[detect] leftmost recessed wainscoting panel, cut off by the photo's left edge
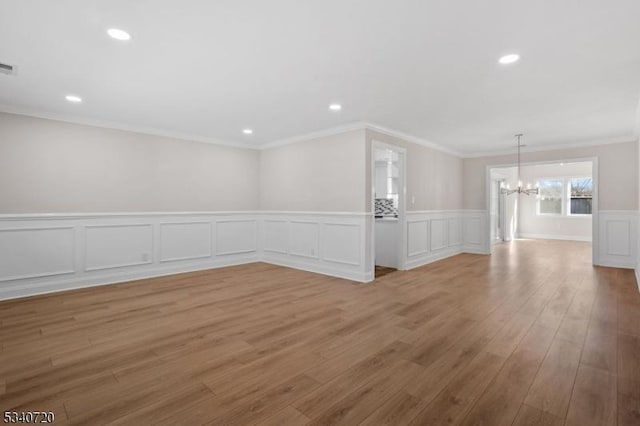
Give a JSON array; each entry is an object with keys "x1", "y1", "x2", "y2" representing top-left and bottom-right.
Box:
[{"x1": 0, "y1": 227, "x2": 75, "y2": 281}]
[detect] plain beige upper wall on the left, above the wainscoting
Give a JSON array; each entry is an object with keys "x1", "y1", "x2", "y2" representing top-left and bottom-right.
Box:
[{"x1": 0, "y1": 113, "x2": 260, "y2": 213}]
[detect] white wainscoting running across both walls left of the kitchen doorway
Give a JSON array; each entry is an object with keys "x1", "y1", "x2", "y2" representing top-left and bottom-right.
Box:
[{"x1": 0, "y1": 211, "x2": 373, "y2": 300}]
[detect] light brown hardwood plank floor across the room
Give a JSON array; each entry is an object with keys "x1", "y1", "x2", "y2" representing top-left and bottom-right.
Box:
[{"x1": 0, "y1": 241, "x2": 640, "y2": 426}]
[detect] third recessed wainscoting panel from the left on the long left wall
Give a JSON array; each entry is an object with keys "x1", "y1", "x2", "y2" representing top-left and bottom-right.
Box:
[{"x1": 160, "y1": 222, "x2": 212, "y2": 262}]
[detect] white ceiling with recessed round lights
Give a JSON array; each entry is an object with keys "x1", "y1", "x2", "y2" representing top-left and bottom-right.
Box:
[{"x1": 0, "y1": 0, "x2": 640, "y2": 153}]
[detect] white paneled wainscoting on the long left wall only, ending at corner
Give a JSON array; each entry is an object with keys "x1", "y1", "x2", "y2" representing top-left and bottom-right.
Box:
[{"x1": 0, "y1": 212, "x2": 261, "y2": 300}]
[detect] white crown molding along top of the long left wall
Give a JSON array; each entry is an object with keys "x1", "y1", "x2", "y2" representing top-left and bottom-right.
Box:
[{"x1": 0, "y1": 104, "x2": 259, "y2": 149}]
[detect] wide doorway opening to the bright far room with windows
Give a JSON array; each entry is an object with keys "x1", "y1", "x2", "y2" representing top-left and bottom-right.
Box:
[{"x1": 487, "y1": 158, "x2": 598, "y2": 264}]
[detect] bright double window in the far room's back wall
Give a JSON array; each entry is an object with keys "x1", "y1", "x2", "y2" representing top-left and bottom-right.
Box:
[{"x1": 536, "y1": 177, "x2": 593, "y2": 216}]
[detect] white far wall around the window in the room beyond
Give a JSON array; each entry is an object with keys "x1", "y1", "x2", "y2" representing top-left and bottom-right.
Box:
[{"x1": 519, "y1": 162, "x2": 592, "y2": 241}]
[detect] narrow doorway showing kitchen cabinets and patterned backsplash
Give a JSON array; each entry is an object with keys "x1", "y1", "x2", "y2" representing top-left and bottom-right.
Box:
[{"x1": 371, "y1": 141, "x2": 406, "y2": 278}]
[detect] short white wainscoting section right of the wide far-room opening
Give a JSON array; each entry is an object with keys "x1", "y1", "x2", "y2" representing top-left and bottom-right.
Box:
[{"x1": 598, "y1": 210, "x2": 638, "y2": 268}]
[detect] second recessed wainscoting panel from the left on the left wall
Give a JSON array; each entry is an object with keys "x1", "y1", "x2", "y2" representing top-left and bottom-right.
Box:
[{"x1": 84, "y1": 224, "x2": 153, "y2": 271}]
